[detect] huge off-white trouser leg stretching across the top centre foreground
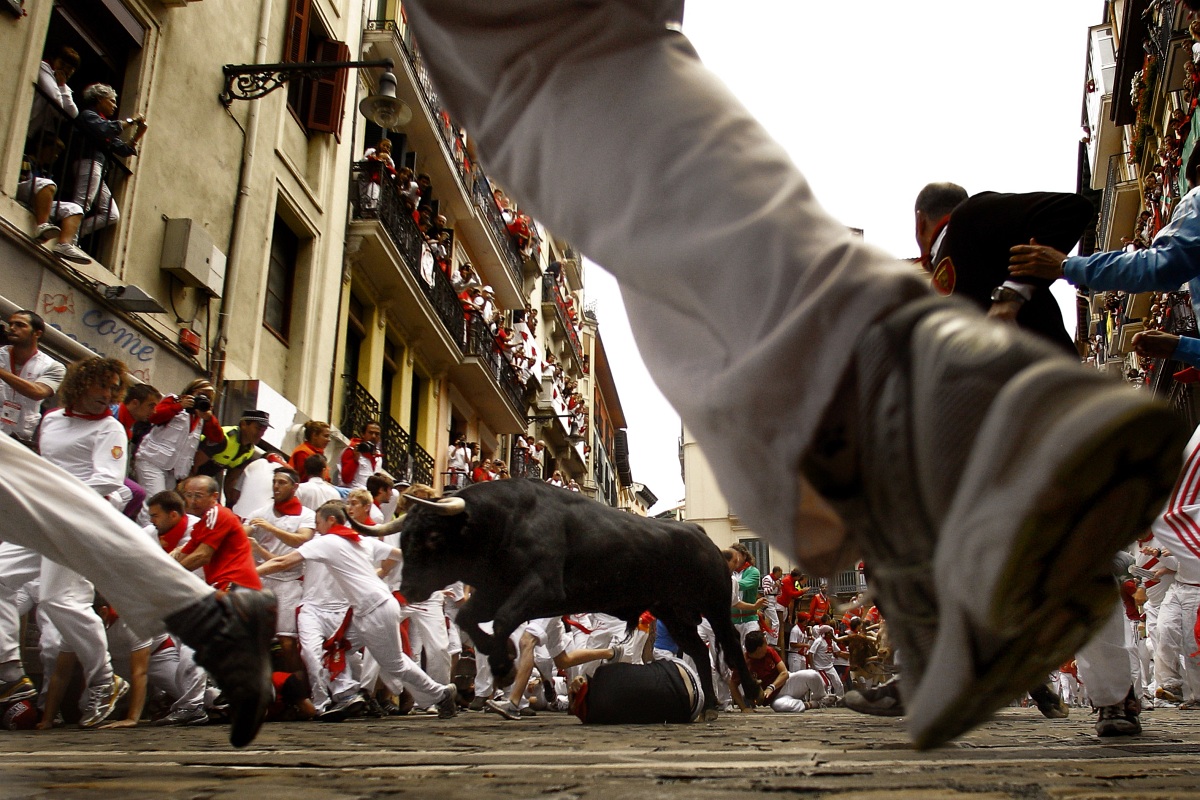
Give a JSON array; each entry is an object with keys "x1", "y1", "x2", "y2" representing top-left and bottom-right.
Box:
[{"x1": 404, "y1": 0, "x2": 929, "y2": 560}]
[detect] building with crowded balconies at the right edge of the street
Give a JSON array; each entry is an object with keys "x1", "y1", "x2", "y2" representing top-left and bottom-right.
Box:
[{"x1": 1076, "y1": 0, "x2": 1200, "y2": 425}]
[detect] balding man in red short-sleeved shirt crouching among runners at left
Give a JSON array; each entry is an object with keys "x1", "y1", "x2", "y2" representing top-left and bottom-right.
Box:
[{"x1": 173, "y1": 475, "x2": 263, "y2": 590}]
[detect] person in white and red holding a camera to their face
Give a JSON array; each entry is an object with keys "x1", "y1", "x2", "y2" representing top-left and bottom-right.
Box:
[{"x1": 134, "y1": 378, "x2": 224, "y2": 497}]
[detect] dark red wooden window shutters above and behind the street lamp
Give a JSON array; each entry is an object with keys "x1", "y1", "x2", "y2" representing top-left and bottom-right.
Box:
[{"x1": 283, "y1": 0, "x2": 350, "y2": 133}]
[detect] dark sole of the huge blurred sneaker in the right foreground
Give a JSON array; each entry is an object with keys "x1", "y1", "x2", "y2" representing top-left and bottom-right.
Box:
[{"x1": 910, "y1": 401, "x2": 1188, "y2": 750}]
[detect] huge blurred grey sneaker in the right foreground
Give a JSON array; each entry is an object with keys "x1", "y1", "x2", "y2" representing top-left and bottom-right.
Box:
[{"x1": 805, "y1": 297, "x2": 1189, "y2": 747}]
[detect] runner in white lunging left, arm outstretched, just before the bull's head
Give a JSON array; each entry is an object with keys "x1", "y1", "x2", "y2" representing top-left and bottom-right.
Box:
[{"x1": 258, "y1": 503, "x2": 458, "y2": 717}]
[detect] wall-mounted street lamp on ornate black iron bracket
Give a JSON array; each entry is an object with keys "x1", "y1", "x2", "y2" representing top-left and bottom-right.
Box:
[{"x1": 218, "y1": 59, "x2": 413, "y2": 128}]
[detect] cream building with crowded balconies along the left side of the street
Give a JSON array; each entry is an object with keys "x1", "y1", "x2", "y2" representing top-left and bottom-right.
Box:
[{"x1": 0, "y1": 0, "x2": 648, "y2": 504}]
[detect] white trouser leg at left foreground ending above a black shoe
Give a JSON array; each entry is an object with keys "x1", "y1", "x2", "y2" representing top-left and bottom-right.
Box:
[{"x1": 0, "y1": 437, "x2": 212, "y2": 637}]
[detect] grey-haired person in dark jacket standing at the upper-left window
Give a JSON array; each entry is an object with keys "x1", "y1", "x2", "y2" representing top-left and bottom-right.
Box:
[{"x1": 71, "y1": 83, "x2": 146, "y2": 242}]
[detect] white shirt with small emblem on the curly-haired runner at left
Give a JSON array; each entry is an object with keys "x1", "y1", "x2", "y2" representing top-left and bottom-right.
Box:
[{"x1": 38, "y1": 408, "x2": 130, "y2": 497}]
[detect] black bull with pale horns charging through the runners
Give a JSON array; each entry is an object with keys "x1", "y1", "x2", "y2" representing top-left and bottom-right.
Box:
[{"x1": 355, "y1": 480, "x2": 758, "y2": 709}]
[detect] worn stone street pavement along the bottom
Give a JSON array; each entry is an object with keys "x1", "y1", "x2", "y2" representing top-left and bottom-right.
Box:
[{"x1": 0, "y1": 709, "x2": 1200, "y2": 800}]
